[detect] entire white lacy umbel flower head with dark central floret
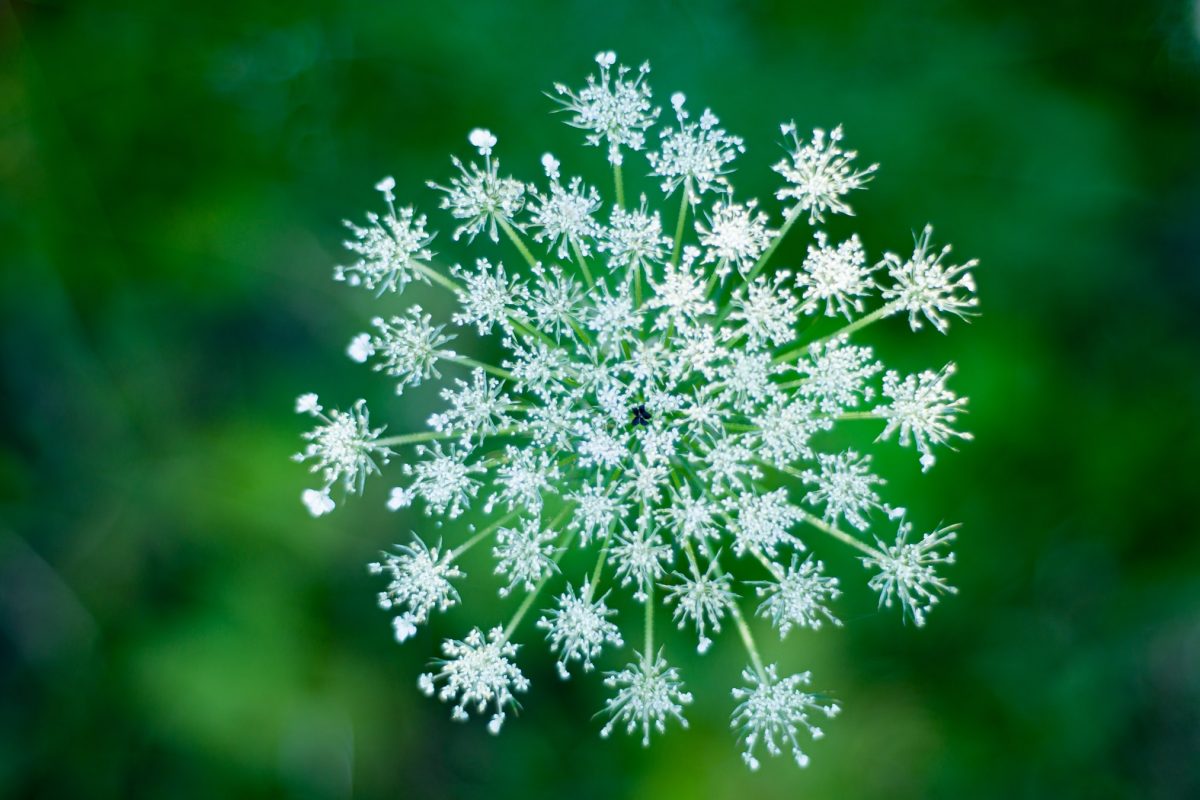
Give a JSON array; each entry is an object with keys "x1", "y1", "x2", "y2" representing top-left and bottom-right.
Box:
[{"x1": 296, "y1": 53, "x2": 977, "y2": 768}]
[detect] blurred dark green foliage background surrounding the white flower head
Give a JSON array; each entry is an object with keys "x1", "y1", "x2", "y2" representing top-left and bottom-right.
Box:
[{"x1": 0, "y1": 0, "x2": 1200, "y2": 800}]
